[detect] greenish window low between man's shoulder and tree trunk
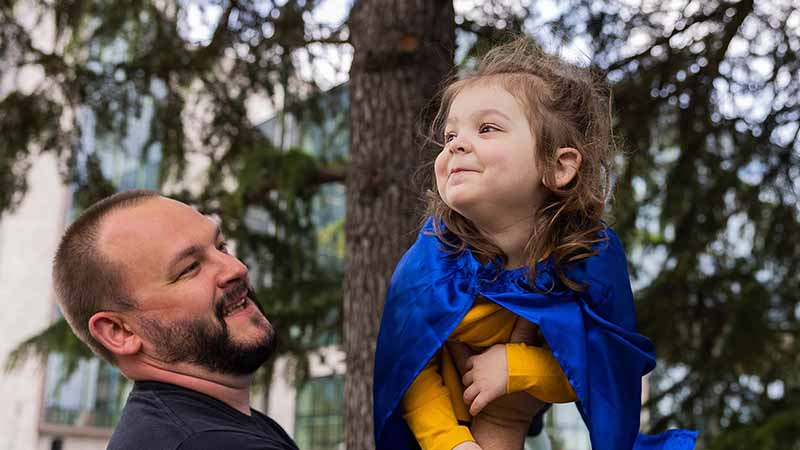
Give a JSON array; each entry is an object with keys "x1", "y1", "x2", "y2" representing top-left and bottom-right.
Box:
[{"x1": 294, "y1": 375, "x2": 344, "y2": 450}]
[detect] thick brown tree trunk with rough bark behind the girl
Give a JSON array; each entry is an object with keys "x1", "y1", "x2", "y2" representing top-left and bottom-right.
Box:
[{"x1": 344, "y1": 0, "x2": 455, "y2": 450}]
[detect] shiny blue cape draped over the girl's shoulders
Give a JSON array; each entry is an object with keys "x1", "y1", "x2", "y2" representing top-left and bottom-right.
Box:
[{"x1": 373, "y1": 219, "x2": 696, "y2": 450}]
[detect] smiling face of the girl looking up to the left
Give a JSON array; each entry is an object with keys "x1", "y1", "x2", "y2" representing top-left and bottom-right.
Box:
[{"x1": 434, "y1": 83, "x2": 545, "y2": 228}]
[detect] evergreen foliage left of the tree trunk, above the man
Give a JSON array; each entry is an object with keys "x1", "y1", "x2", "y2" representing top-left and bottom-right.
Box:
[{"x1": 0, "y1": 0, "x2": 347, "y2": 390}]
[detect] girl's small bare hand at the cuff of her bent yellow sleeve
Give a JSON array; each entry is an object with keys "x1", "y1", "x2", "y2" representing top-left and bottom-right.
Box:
[{"x1": 462, "y1": 344, "x2": 508, "y2": 416}]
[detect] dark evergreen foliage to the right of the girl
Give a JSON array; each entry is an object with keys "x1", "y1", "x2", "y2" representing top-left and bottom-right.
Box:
[{"x1": 557, "y1": 1, "x2": 800, "y2": 449}]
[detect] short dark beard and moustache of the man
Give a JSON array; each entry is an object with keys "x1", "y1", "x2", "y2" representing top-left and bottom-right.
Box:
[{"x1": 141, "y1": 286, "x2": 276, "y2": 375}]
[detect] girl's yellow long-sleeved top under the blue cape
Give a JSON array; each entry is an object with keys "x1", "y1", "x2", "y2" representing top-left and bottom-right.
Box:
[{"x1": 402, "y1": 297, "x2": 576, "y2": 450}]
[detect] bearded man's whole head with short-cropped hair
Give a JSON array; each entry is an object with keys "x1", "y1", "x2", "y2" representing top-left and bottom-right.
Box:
[{"x1": 53, "y1": 191, "x2": 274, "y2": 375}]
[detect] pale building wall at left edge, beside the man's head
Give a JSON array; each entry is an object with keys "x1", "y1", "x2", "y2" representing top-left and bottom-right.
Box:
[{"x1": 0, "y1": 154, "x2": 68, "y2": 450}]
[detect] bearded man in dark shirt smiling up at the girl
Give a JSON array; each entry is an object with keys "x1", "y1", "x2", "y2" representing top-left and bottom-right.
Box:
[{"x1": 53, "y1": 190, "x2": 297, "y2": 450}]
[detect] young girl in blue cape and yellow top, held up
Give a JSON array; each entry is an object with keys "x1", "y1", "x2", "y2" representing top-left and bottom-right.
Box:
[{"x1": 374, "y1": 38, "x2": 695, "y2": 450}]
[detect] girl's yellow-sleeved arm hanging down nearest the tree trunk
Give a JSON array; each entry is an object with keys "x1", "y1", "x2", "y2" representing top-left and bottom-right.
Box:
[{"x1": 401, "y1": 350, "x2": 480, "y2": 450}]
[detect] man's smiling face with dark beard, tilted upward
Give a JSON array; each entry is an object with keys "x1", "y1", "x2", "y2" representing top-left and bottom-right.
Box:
[{"x1": 99, "y1": 197, "x2": 275, "y2": 375}]
